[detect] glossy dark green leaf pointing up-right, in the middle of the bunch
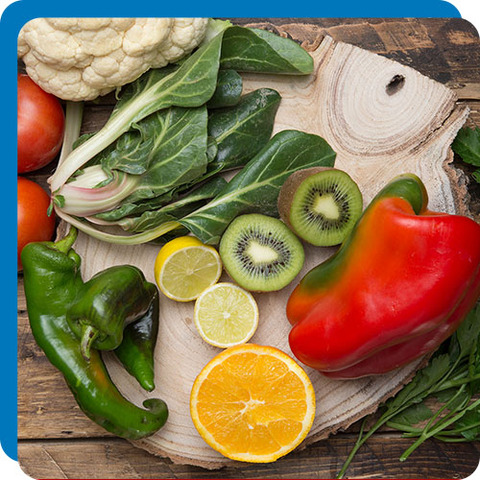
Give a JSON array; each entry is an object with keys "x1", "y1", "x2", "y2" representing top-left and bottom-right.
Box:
[{"x1": 208, "y1": 88, "x2": 281, "y2": 174}]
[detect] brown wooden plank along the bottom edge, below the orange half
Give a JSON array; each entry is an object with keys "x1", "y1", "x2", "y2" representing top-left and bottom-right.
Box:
[{"x1": 18, "y1": 434, "x2": 480, "y2": 479}]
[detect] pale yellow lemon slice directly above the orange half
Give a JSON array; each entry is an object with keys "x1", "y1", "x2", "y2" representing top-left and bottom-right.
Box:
[{"x1": 193, "y1": 282, "x2": 258, "y2": 348}]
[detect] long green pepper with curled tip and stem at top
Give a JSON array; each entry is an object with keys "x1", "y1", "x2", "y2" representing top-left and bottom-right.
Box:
[{"x1": 21, "y1": 228, "x2": 168, "y2": 440}]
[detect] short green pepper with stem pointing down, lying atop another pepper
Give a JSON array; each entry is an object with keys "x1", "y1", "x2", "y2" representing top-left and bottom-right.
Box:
[{"x1": 67, "y1": 265, "x2": 158, "y2": 359}]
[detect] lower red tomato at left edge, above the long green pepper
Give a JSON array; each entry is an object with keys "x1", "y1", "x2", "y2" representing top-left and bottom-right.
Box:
[{"x1": 17, "y1": 177, "x2": 55, "y2": 270}]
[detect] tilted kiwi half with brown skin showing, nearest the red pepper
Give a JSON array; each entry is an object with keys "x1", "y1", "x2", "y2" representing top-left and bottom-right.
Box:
[{"x1": 278, "y1": 167, "x2": 363, "y2": 247}]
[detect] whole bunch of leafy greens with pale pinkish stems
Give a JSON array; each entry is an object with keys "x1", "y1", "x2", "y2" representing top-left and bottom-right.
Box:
[{"x1": 49, "y1": 20, "x2": 320, "y2": 244}]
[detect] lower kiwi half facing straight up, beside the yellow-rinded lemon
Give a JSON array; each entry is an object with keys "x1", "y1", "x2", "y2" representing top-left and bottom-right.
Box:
[{"x1": 219, "y1": 213, "x2": 305, "y2": 292}]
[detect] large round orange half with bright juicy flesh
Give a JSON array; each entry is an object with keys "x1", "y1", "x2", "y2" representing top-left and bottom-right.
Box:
[{"x1": 190, "y1": 343, "x2": 315, "y2": 463}]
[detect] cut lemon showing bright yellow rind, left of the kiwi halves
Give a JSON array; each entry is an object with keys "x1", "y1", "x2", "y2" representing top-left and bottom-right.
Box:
[{"x1": 155, "y1": 236, "x2": 222, "y2": 302}]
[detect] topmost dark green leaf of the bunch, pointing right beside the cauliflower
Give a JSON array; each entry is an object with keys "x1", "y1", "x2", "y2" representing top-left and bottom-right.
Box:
[{"x1": 220, "y1": 26, "x2": 313, "y2": 75}]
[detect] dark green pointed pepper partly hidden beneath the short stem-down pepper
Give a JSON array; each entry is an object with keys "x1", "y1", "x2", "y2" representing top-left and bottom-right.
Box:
[{"x1": 115, "y1": 290, "x2": 159, "y2": 392}]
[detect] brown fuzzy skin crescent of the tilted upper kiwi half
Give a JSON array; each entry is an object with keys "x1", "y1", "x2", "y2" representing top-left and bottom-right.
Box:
[{"x1": 277, "y1": 167, "x2": 361, "y2": 247}]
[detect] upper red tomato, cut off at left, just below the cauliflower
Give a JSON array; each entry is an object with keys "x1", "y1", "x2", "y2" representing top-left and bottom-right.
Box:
[{"x1": 17, "y1": 74, "x2": 65, "y2": 173}]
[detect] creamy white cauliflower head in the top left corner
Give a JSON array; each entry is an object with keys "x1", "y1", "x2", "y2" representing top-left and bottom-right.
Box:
[{"x1": 18, "y1": 18, "x2": 208, "y2": 101}]
